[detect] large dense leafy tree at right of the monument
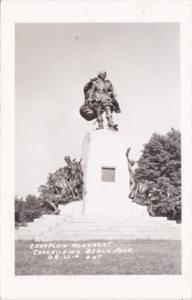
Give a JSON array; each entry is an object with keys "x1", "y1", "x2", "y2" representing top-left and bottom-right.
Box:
[{"x1": 135, "y1": 128, "x2": 181, "y2": 221}]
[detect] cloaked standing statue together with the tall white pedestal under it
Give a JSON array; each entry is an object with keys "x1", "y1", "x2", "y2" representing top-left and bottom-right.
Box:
[{"x1": 80, "y1": 71, "x2": 136, "y2": 215}]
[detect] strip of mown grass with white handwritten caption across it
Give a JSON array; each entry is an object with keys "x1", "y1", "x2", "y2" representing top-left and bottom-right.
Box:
[{"x1": 15, "y1": 240, "x2": 181, "y2": 275}]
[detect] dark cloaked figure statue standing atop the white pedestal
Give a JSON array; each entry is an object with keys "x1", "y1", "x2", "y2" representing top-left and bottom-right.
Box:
[{"x1": 80, "y1": 71, "x2": 121, "y2": 130}]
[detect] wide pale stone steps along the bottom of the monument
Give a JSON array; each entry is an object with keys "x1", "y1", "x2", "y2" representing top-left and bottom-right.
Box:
[{"x1": 16, "y1": 211, "x2": 180, "y2": 241}]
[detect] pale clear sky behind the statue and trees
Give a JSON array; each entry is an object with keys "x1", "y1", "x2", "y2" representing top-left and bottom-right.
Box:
[{"x1": 15, "y1": 23, "x2": 180, "y2": 197}]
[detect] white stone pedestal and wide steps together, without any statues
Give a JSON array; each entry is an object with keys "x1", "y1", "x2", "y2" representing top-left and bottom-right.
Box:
[{"x1": 16, "y1": 130, "x2": 181, "y2": 241}]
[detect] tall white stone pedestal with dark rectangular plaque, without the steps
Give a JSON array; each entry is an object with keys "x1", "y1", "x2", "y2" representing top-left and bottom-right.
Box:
[{"x1": 82, "y1": 129, "x2": 146, "y2": 216}]
